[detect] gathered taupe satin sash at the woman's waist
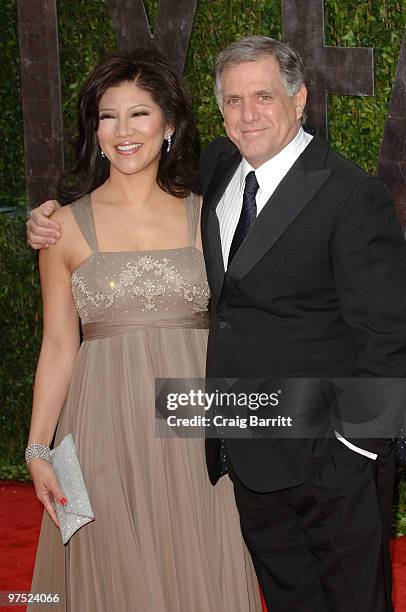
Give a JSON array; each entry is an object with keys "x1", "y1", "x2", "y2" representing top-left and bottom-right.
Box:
[{"x1": 82, "y1": 311, "x2": 209, "y2": 341}]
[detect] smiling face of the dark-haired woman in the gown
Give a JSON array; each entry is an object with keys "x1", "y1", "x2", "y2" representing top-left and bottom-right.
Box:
[{"x1": 97, "y1": 83, "x2": 173, "y2": 174}]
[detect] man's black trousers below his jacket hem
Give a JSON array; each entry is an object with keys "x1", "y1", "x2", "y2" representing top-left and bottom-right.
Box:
[{"x1": 229, "y1": 441, "x2": 393, "y2": 612}]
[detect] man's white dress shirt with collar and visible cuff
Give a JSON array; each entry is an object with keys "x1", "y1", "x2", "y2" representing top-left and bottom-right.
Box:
[{"x1": 216, "y1": 127, "x2": 377, "y2": 459}]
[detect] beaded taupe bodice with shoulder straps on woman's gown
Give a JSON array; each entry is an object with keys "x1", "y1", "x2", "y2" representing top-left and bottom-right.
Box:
[{"x1": 71, "y1": 196, "x2": 209, "y2": 325}]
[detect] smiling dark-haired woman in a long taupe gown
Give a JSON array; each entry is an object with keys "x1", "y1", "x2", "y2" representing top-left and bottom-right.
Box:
[{"x1": 29, "y1": 52, "x2": 261, "y2": 612}]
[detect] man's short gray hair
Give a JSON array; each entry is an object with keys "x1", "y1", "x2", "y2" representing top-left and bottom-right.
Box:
[{"x1": 213, "y1": 36, "x2": 305, "y2": 106}]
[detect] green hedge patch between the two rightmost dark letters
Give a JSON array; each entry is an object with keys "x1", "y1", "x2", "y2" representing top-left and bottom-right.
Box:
[{"x1": 325, "y1": 0, "x2": 406, "y2": 174}]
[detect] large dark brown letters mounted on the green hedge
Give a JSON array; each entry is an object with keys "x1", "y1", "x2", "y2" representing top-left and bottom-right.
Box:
[{"x1": 12, "y1": 0, "x2": 406, "y2": 220}]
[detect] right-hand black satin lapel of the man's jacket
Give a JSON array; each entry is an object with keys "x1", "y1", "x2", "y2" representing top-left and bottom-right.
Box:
[{"x1": 221, "y1": 158, "x2": 331, "y2": 299}]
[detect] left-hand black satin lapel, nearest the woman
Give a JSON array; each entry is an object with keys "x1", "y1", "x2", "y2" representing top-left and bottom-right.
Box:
[{"x1": 202, "y1": 148, "x2": 241, "y2": 302}]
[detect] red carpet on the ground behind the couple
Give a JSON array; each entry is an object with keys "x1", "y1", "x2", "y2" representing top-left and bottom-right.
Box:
[{"x1": 0, "y1": 482, "x2": 406, "y2": 612}]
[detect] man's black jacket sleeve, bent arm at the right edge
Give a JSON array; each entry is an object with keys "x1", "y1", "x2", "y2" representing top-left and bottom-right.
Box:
[{"x1": 332, "y1": 177, "x2": 406, "y2": 453}]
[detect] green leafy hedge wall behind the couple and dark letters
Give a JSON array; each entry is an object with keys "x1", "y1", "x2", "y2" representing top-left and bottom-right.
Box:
[{"x1": 0, "y1": 0, "x2": 406, "y2": 533}]
